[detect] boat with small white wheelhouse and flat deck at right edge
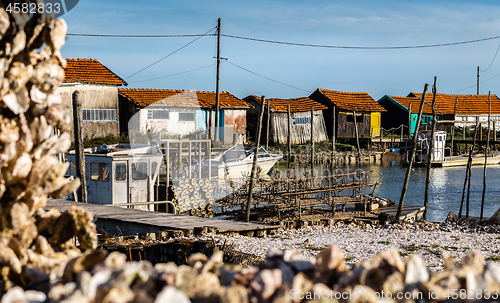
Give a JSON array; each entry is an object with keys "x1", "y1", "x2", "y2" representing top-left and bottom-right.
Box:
[{"x1": 401, "y1": 130, "x2": 500, "y2": 167}]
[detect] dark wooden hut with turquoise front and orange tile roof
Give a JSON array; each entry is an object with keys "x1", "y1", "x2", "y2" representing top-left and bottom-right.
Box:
[{"x1": 377, "y1": 95, "x2": 443, "y2": 134}]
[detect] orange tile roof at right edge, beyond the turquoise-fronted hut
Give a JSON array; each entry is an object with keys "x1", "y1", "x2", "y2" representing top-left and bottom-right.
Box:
[{"x1": 408, "y1": 93, "x2": 500, "y2": 115}]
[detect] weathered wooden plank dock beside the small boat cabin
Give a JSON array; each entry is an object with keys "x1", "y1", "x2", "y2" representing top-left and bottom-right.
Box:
[{"x1": 45, "y1": 199, "x2": 279, "y2": 236}]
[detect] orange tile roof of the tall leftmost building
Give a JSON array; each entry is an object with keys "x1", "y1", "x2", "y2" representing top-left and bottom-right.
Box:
[{"x1": 63, "y1": 59, "x2": 127, "y2": 85}]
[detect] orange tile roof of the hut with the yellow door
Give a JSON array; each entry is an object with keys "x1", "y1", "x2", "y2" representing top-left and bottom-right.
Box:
[{"x1": 318, "y1": 88, "x2": 386, "y2": 112}]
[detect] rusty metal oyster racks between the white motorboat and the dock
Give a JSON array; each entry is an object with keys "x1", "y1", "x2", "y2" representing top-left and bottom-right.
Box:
[{"x1": 213, "y1": 169, "x2": 376, "y2": 220}]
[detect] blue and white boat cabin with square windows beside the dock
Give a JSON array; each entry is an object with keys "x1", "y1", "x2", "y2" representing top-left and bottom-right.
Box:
[{"x1": 67, "y1": 144, "x2": 162, "y2": 211}]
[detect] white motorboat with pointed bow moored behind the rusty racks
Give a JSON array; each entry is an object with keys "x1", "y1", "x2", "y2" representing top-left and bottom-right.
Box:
[{"x1": 203, "y1": 144, "x2": 283, "y2": 180}]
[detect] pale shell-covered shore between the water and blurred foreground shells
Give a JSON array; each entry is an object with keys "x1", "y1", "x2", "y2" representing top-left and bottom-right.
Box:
[{"x1": 214, "y1": 222, "x2": 500, "y2": 271}]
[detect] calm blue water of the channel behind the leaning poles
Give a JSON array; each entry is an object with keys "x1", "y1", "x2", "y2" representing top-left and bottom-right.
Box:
[{"x1": 278, "y1": 162, "x2": 500, "y2": 221}]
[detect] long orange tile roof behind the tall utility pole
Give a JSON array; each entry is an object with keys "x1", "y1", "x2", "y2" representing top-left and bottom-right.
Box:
[{"x1": 118, "y1": 88, "x2": 252, "y2": 108}]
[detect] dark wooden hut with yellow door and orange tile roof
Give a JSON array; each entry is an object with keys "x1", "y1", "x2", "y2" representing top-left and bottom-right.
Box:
[{"x1": 309, "y1": 88, "x2": 386, "y2": 138}]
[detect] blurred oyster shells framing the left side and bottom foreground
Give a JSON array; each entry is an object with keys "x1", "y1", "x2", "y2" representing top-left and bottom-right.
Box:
[{"x1": 0, "y1": 1, "x2": 500, "y2": 303}]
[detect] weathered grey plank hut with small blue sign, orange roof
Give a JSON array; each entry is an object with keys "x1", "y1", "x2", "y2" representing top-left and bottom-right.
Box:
[{"x1": 243, "y1": 96, "x2": 328, "y2": 144}]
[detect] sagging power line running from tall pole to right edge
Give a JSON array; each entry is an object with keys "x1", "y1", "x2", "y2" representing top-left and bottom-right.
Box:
[{"x1": 221, "y1": 34, "x2": 500, "y2": 49}]
